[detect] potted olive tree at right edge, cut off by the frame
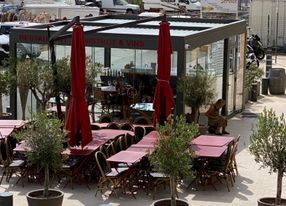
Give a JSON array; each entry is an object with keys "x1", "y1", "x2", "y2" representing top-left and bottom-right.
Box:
[{"x1": 249, "y1": 108, "x2": 286, "y2": 206}]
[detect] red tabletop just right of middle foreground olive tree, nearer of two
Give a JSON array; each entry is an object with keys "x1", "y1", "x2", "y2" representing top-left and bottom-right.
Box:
[{"x1": 191, "y1": 144, "x2": 227, "y2": 158}]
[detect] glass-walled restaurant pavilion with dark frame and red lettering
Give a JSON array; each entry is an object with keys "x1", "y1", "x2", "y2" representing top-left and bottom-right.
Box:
[{"x1": 10, "y1": 15, "x2": 246, "y2": 119}]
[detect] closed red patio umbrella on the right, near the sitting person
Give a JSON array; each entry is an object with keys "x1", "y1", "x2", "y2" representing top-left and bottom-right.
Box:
[{"x1": 153, "y1": 20, "x2": 175, "y2": 125}]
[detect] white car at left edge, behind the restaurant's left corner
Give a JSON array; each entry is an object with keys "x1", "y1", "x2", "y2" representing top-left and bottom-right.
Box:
[{"x1": 0, "y1": 21, "x2": 42, "y2": 61}]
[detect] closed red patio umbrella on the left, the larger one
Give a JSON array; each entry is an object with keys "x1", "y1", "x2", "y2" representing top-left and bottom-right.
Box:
[{"x1": 65, "y1": 24, "x2": 92, "y2": 147}]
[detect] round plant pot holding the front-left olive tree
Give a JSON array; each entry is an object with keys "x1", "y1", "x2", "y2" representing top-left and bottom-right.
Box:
[{"x1": 26, "y1": 189, "x2": 64, "y2": 206}]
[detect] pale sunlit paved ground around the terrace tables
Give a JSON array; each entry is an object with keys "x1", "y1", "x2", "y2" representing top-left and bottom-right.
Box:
[{"x1": 0, "y1": 56, "x2": 286, "y2": 206}]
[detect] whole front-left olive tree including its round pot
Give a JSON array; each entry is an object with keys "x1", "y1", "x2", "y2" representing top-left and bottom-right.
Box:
[{"x1": 16, "y1": 113, "x2": 67, "y2": 206}]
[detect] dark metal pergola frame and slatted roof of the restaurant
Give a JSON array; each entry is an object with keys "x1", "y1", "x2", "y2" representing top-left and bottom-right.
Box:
[{"x1": 10, "y1": 15, "x2": 246, "y2": 118}]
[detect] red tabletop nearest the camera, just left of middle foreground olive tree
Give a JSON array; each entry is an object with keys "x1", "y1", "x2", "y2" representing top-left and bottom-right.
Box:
[{"x1": 107, "y1": 150, "x2": 146, "y2": 164}]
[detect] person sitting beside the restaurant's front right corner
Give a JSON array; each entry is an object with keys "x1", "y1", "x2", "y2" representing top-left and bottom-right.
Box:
[{"x1": 206, "y1": 99, "x2": 229, "y2": 135}]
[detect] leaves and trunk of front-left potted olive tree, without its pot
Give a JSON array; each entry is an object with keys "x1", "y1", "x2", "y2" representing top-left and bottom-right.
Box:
[{"x1": 15, "y1": 113, "x2": 67, "y2": 194}]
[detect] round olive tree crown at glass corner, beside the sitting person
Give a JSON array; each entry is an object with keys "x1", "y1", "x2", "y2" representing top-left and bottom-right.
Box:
[{"x1": 178, "y1": 70, "x2": 215, "y2": 108}]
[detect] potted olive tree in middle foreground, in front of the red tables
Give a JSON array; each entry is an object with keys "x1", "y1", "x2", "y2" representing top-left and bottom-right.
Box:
[{"x1": 149, "y1": 116, "x2": 198, "y2": 206}]
